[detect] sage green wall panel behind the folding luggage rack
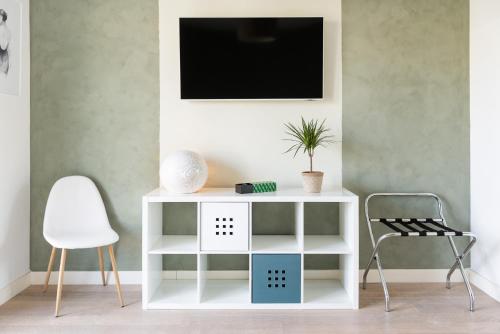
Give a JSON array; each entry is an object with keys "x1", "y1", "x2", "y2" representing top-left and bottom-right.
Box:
[{"x1": 342, "y1": 0, "x2": 469, "y2": 268}]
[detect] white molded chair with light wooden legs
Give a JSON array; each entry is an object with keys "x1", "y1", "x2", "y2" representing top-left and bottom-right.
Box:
[{"x1": 43, "y1": 176, "x2": 124, "y2": 317}]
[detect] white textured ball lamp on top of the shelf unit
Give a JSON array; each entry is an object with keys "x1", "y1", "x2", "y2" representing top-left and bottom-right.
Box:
[{"x1": 160, "y1": 150, "x2": 208, "y2": 194}]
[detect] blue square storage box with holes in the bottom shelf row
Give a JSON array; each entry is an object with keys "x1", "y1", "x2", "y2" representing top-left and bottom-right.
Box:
[{"x1": 252, "y1": 254, "x2": 301, "y2": 303}]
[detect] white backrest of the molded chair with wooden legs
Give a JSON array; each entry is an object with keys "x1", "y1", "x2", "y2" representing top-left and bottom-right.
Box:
[{"x1": 43, "y1": 176, "x2": 111, "y2": 236}]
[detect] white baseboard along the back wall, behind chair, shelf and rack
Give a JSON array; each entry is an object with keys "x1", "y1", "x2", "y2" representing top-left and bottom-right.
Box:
[{"x1": 31, "y1": 269, "x2": 462, "y2": 285}]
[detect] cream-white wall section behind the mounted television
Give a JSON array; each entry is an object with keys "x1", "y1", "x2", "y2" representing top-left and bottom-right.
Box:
[{"x1": 159, "y1": 0, "x2": 342, "y2": 188}]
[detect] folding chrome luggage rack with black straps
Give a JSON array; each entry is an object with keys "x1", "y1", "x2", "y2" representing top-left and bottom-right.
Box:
[{"x1": 363, "y1": 193, "x2": 477, "y2": 312}]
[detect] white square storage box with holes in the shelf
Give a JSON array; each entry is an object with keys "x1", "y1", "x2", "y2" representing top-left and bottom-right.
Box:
[{"x1": 201, "y1": 203, "x2": 248, "y2": 251}]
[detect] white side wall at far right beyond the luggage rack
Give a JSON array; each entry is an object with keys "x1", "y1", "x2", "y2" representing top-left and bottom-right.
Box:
[{"x1": 470, "y1": 0, "x2": 500, "y2": 300}]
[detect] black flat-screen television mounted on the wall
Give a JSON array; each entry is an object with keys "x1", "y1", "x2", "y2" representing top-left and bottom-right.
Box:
[{"x1": 179, "y1": 17, "x2": 323, "y2": 100}]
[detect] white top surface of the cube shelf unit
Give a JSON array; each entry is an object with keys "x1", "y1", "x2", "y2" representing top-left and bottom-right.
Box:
[{"x1": 144, "y1": 188, "x2": 358, "y2": 202}]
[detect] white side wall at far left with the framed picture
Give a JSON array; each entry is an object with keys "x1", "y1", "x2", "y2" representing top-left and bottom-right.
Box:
[{"x1": 0, "y1": 0, "x2": 30, "y2": 304}]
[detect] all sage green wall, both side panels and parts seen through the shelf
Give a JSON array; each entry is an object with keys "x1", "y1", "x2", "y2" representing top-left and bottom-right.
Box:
[{"x1": 31, "y1": 0, "x2": 469, "y2": 271}]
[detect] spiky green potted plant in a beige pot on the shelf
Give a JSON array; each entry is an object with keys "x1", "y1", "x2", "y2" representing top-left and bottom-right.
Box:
[{"x1": 285, "y1": 117, "x2": 333, "y2": 193}]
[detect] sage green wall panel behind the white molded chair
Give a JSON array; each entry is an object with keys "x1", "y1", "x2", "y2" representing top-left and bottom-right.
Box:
[{"x1": 31, "y1": 0, "x2": 159, "y2": 271}]
